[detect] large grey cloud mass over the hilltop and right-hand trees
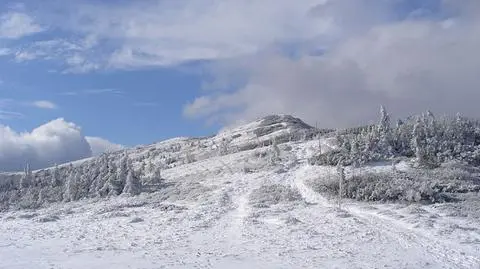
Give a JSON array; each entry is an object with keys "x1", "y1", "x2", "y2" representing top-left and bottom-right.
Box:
[{"x1": 184, "y1": 1, "x2": 480, "y2": 127}]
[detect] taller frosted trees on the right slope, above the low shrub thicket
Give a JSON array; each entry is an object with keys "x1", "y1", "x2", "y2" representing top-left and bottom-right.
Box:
[{"x1": 311, "y1": 107, "x2": 480, "y2": 167}]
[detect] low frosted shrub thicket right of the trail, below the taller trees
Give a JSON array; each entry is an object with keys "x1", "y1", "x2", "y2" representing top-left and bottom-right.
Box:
[{"x1": 307, "y1": 168, "x2": 480, "y2": 203}]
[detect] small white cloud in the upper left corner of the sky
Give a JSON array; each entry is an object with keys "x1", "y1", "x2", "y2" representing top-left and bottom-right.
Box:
[{"x1": 0, "y1": 12, "x2": 44, "y2": 39}]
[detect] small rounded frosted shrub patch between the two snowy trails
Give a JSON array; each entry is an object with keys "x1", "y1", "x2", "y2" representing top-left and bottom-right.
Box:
[{"x1": 249, "y1": 184, "x2": 302, "y2": 207}]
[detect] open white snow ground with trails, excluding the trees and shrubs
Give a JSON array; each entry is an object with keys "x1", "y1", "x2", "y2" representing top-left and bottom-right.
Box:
[{"x1": 0, "y1": 115, "x2": 480, "y2": 269}]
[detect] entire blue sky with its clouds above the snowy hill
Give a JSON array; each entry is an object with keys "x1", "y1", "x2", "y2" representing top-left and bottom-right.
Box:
[{"x1": 0, "y1": 0, "x2": 480, "y2": 168}]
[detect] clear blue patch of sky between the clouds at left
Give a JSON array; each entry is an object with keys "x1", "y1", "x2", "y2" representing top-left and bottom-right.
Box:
[{"x1": 0, "y1": 57, "x2": 218, "y2": 145}]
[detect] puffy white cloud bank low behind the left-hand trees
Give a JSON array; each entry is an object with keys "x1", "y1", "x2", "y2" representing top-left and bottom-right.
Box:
[{"x1": 0, "y1": 118, "x2": 123, "y2": 171}]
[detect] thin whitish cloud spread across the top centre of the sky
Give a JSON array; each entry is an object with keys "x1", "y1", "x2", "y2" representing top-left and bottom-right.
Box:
[{"x1": 79, "y1": 0, "x2": 329, "y2": 68}]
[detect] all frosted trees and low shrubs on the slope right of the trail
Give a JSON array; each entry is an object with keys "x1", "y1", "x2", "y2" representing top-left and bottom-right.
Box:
[{"x1": 309, "y1": 107, "x2": 480, "y2": 203}]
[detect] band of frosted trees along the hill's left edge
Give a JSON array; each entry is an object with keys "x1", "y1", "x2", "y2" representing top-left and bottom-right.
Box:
[{"x1": 0, "y1": 153, "x2": 161, "y2": 209}]
